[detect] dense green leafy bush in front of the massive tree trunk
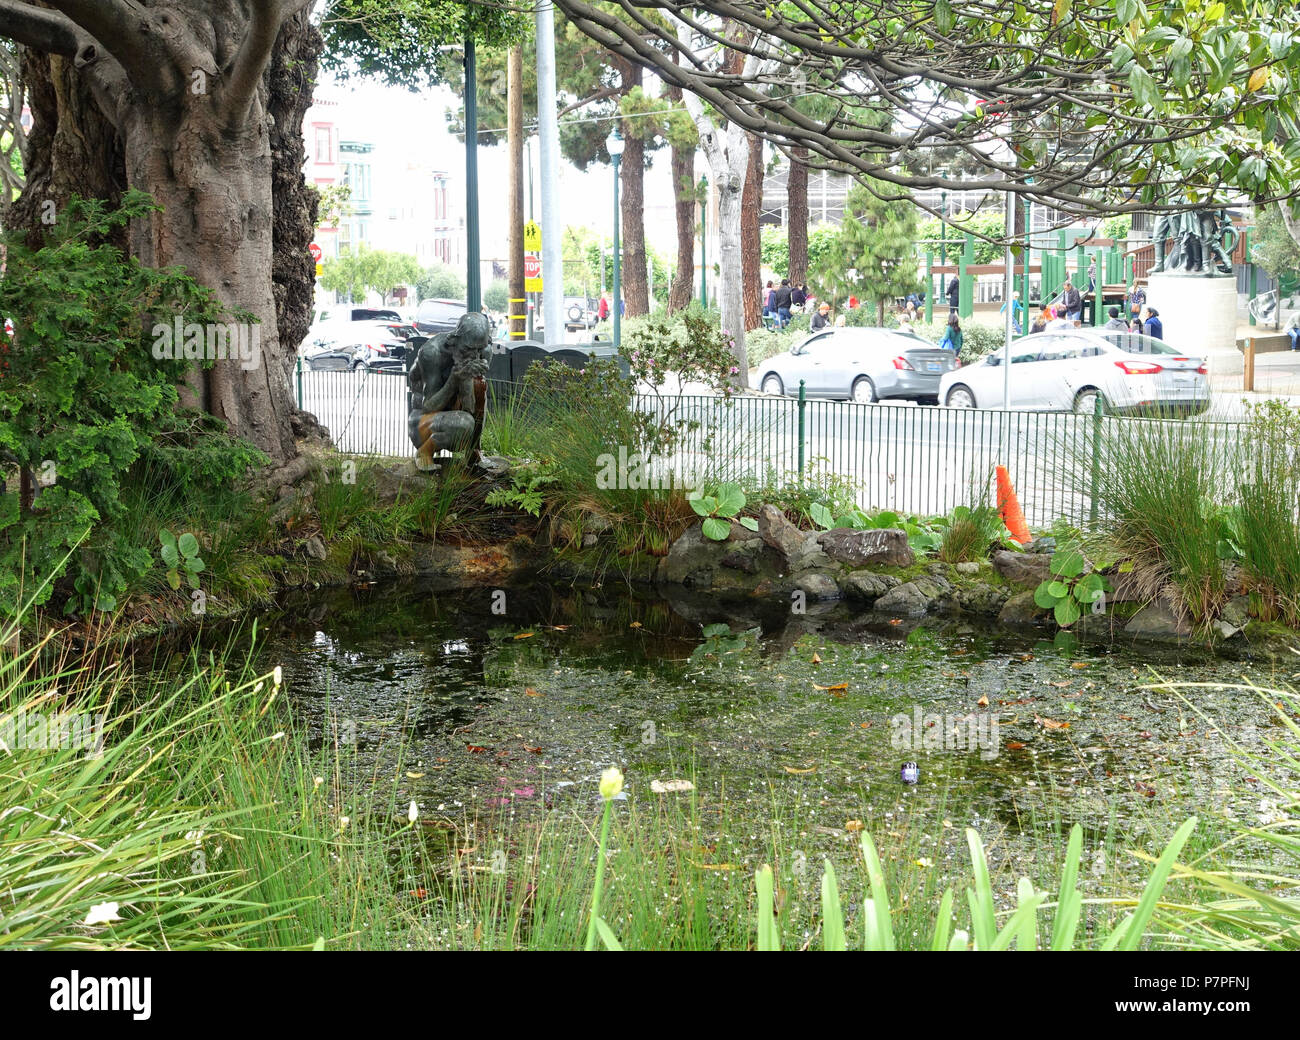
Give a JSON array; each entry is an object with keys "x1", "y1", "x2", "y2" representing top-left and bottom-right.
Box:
[{"x1": 0, "y1": 191, "x2": 263, "y2": 616}]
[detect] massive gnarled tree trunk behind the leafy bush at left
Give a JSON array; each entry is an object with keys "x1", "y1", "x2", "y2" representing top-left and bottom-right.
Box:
[{"x1": 0, "y1": 0, "x2": 321, "y2": 463}]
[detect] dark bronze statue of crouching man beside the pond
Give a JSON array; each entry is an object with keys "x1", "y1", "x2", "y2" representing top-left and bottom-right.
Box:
[{"x1": 407, "y1": 311, "x2": 491, "y2": 471}]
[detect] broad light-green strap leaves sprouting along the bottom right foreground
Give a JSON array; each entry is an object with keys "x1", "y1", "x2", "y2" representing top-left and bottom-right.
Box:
[{"x1": 755, "y1": 816, "x2": 1196, "y2": 950}]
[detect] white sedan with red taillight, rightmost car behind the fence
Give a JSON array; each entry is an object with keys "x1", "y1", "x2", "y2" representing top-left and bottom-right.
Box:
[{"x1": 939, "y1": 329, "x2": 1210, "y2": 415}]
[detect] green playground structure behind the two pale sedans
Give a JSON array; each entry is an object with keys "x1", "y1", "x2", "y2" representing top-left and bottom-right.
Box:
[{"x1": 918, "y1": 226, "x2": 1258, "y2": 325}]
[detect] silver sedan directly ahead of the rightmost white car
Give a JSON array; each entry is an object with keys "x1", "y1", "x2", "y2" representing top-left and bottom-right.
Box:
[{"x1": 758, "y1": 328, "x2": 957, "y2": 404}]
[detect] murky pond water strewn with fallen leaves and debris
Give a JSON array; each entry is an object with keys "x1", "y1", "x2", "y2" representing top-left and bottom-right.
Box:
[{"x1": 258, "y1": 586, "x2": 1290, "y2": 873}]
